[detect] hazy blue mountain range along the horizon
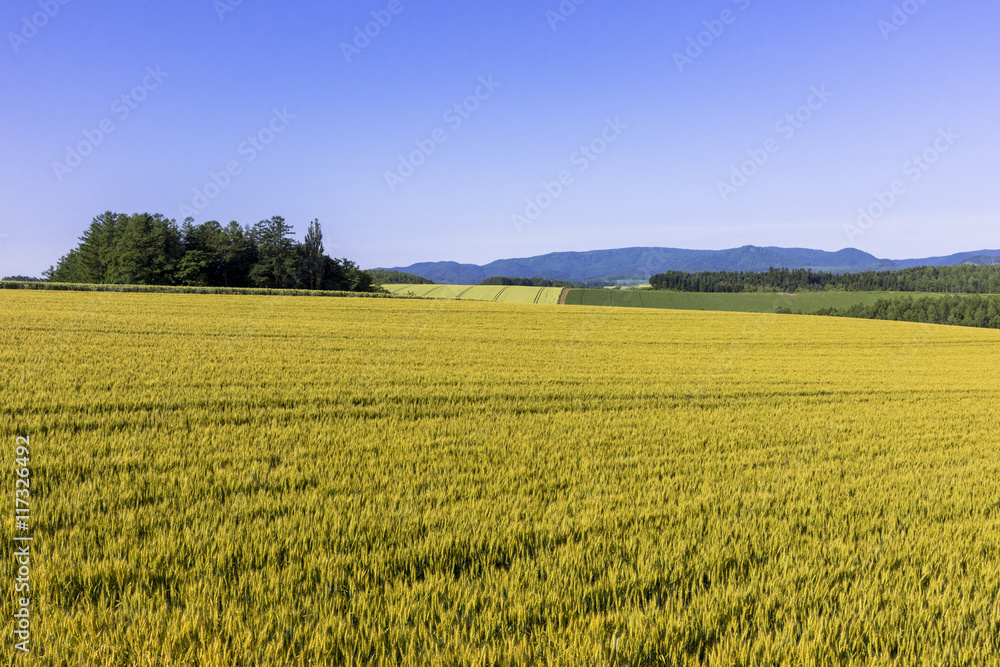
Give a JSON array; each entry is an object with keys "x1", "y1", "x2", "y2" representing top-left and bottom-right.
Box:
[{"x1": 372, "y1": 246, "x2": 1000, "y2": 285}]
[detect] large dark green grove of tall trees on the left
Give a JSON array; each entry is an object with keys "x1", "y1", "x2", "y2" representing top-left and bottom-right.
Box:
[{"x1": 44, "y1": 212, "x2": 373, "y2": 292}]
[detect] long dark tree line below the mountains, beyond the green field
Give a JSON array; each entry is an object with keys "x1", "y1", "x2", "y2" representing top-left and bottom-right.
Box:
[{"x1": 649, "y1": 264, "x2": 1000, "y2": 294}]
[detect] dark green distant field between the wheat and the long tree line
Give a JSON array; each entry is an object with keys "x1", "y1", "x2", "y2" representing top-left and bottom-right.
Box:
[{"x1": 566, "y1": 289, "x2": 938, "y2": 314}]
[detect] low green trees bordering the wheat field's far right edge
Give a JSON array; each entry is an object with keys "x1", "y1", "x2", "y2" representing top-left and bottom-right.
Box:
[{"x1": 814, "y1": 294, "x2": 1000, "y2": 329}]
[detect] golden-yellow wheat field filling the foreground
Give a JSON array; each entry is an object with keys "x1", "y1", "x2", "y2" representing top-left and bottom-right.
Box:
[{"x1": 0, "y1": 292, "x2": 1000, "y2": 667}]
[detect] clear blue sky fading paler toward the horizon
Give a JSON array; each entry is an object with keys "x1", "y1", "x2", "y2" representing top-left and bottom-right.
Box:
[{"x1": 0, "y1": 0, "x2": 1000, "y2": 275}]
